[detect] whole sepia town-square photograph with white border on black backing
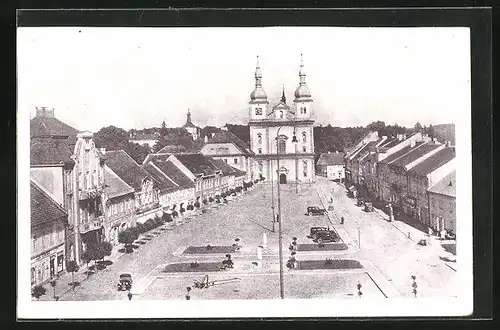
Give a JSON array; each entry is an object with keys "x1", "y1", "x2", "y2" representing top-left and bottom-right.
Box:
[{"x1": 17, "y1": 19, "x2": 473, "y2": 318}]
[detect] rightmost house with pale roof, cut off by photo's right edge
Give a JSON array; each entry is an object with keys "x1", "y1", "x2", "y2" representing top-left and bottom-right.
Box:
[{"x1": 428, "y1": 171, "x2": 457, "y2": 234}]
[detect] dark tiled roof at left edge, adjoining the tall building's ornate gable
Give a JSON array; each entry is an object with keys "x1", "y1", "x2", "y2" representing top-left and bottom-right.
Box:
[{"x1": 30, "y1": 138, "x2": 76, "y2": 165}]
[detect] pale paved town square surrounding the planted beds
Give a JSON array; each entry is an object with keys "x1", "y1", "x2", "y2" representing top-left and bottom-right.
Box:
[{"x1": 41, "y1": 178, "x2": 455, "y2": 300}]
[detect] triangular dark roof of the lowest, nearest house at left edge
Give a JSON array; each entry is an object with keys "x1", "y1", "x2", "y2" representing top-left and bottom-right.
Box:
[{"x1": 30, "y1": 181, "x2": 68, "y2": 227}]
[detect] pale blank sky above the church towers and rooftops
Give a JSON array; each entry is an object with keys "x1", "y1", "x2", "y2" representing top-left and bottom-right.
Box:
[{"x1": 17, "y1": 27, "x2": 471, "y2": 132}]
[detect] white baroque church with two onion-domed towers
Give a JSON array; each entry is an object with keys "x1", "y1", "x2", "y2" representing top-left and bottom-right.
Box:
[{"x1": 248, "y1": 54, "x2": 315, "y2": 184}]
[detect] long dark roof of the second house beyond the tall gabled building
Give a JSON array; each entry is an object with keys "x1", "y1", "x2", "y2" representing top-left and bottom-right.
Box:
[{"x1": 101, "y1": 150, "x2": 156, "y2": 191}]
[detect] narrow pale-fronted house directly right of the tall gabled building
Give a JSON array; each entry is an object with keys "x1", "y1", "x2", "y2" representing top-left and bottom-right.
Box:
[{"x1": 104, "y1": 165, "x2": 135, "y2": 245}]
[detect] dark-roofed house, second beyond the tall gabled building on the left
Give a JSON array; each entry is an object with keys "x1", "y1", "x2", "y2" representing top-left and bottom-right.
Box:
[{"x1": 106, "y1": 150, "x2": 163, "y2": 223}]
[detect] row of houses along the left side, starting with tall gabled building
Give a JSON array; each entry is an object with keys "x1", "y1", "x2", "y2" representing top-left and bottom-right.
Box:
[{"x1": 30, "y1": 108, "x2": 251, "y2": 284}]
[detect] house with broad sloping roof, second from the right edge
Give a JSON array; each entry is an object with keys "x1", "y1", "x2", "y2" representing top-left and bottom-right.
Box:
[{"x1": 403, "y1": 145, "x2": 456, "y2": 229}]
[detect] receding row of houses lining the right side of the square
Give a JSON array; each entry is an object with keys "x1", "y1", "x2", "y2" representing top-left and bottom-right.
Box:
[{"x1": 344, "y1": 132, "x2": 456, "y2": 233}]
